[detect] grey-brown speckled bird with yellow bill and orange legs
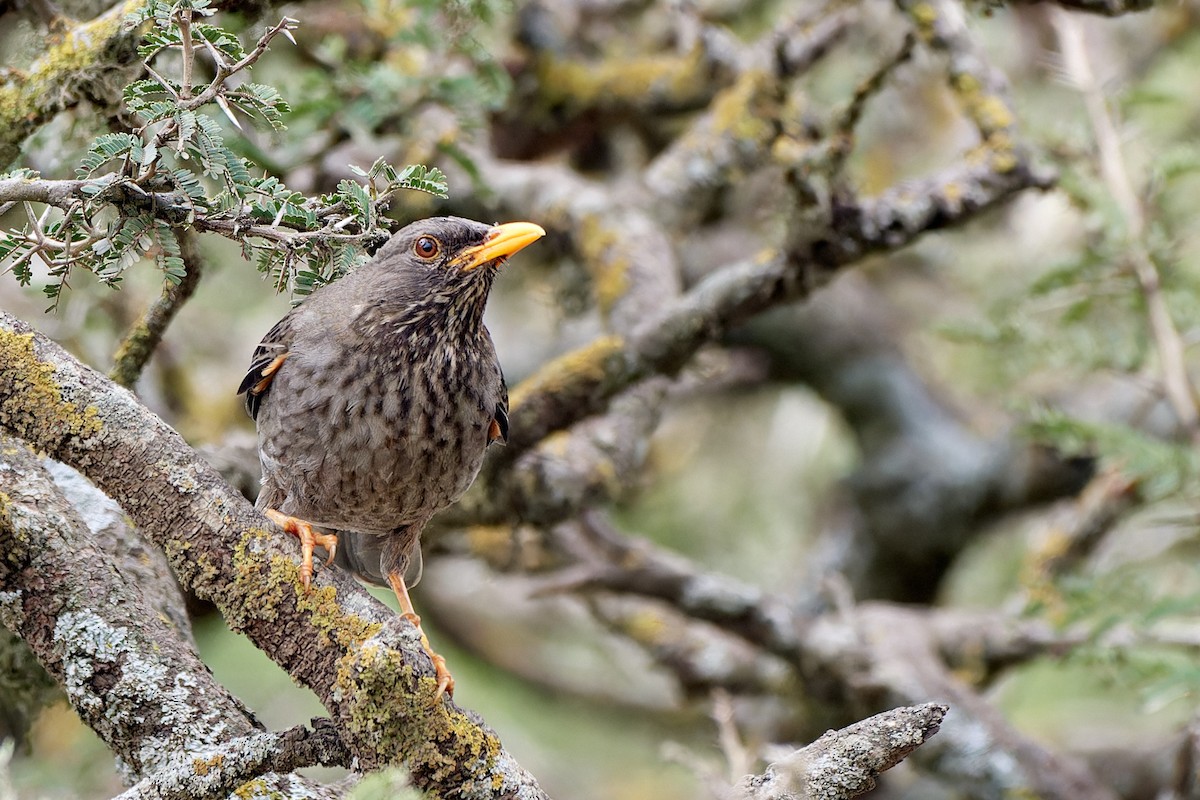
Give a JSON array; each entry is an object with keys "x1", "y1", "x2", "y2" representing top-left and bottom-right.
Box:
[{"x1": 238, "y1": 217, "x2": 546, "y2": 702}]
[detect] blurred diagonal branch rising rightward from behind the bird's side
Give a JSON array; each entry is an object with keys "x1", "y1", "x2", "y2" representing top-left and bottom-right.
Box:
[{"x1": 485, "y1": 155, "x2": 1050, "y2": 477}]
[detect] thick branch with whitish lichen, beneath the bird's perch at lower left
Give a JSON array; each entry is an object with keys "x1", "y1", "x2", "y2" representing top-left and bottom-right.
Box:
[{"x1": 0, "y1": 435, "x2": 309, "y2": 786}]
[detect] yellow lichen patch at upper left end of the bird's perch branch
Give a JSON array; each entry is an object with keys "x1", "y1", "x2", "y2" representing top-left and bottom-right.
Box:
[{"x1": 0, "y1": 329, "x2": 102, "y2": 452}]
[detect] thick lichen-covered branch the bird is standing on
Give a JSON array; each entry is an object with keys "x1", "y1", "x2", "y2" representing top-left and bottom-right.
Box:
[{"x1": 0, "y1": 313, "x2": 544, "y2": 799}]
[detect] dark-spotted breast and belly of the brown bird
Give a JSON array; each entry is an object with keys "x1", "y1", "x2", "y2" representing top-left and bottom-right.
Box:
[{"x1": 259, "y1": 335, "x2": 503, "y2": 533}]
